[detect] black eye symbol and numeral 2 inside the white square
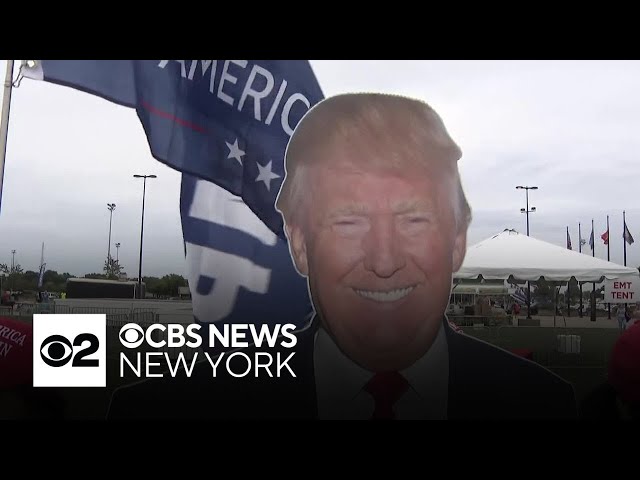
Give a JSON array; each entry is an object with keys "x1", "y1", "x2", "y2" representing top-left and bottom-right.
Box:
[{"x1": 40, "y1": 333, "x2": 100, "y2": 367}]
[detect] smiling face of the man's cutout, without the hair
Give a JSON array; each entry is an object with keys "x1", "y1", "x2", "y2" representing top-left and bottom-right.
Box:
[{"x1": 287, "y1": 146, "x2": 466, "y2": 371}]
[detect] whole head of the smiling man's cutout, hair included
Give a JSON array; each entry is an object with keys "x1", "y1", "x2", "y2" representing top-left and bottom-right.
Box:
[{"x1": 276, "y1": 93, "x2": 470, "y2": 371}]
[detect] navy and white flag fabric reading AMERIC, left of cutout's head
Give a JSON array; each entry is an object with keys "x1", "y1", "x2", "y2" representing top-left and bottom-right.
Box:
[{"x1": 24, "y1": 60, "x2": 323, "y2": 332}]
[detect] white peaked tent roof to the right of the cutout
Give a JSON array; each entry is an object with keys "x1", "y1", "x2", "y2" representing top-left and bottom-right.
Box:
[{"x1": 454, "y1": 229, "x2": 639, "y2": 282}]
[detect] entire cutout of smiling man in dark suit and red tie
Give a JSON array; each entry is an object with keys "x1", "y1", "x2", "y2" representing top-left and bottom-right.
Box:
[{"x1": 110, "y1": 93, "x2": 576, "y2": 420}]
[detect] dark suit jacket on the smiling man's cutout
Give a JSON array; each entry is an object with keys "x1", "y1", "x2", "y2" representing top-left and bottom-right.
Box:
[{"x1": 107, "y1": 319, "x2": 577, "y2": 419}]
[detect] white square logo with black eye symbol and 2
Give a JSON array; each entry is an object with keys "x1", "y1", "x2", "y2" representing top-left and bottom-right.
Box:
[{"x1": 33, "y1": 314, "x2": 107, "y2": 387}]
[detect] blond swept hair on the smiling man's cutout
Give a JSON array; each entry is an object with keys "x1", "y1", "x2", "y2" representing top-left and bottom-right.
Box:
[{"x1": 276, "y1": 93, "x2": 471, "y2": 229}]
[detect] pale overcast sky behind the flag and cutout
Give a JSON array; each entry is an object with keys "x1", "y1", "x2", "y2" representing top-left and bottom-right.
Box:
[{"x1": 0, "y1": 61, "x2": 640, "y2": 277}]
